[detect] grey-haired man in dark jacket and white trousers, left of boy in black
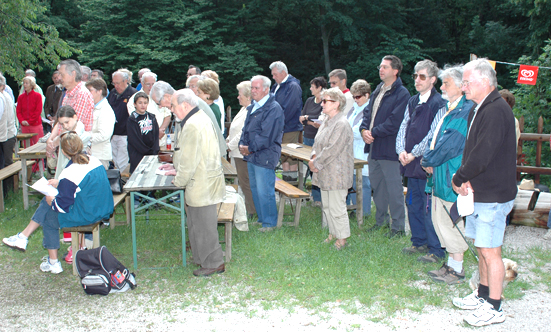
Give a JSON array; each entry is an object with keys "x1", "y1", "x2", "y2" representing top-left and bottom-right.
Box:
[{"x1": 107, "y1": 70, "x2": 137, "y2": 172}]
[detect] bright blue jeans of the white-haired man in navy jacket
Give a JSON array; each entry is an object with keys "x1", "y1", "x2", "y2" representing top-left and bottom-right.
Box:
[{"x1": 247, "y1": 163, "x2": 277, "y2": 227}]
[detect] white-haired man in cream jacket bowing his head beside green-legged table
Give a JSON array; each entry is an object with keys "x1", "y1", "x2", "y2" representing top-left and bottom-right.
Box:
[{"x1": 162, "y1": 89, "x2": 226, "y2": 277}]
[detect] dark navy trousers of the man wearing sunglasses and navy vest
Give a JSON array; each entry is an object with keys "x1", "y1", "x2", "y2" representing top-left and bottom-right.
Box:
[{"x1": 406, "y1": 178, "x2": 445, "y2": 257}]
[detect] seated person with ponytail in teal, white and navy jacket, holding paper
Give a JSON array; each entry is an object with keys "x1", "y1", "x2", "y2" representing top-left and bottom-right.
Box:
[{"x1": 2, "y1": 131, "x2": 114, "y2": 274}]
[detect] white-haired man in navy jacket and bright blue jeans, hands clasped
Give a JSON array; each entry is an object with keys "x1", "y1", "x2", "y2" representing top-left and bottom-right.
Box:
[{"x1": 239, "y1": 75, "x2": 285, "y2": 232}]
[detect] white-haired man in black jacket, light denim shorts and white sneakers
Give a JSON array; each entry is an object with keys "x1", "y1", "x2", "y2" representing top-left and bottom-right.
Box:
[{"x1": 452, "y1": 59, "x2": 517, "y2": 326}]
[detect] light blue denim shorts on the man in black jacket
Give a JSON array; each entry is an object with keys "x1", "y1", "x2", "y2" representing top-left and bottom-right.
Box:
[{"x1": 465, "y1": 200, "x2": 514, "y2": 248}]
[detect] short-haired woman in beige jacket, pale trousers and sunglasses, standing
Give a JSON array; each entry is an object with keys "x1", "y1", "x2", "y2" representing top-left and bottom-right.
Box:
[{"x1": 308, "y1": 88, "x2": 354, "y2": 250}]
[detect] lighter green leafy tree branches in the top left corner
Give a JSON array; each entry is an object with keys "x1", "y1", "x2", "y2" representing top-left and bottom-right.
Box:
[{"x1": 0, "y1": 0, "x2": 76, "y2": 77}]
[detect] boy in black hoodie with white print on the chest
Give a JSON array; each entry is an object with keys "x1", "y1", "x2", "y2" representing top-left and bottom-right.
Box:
[{"x1": 126, "y1": 91, "x2": 159, "y2": 173}]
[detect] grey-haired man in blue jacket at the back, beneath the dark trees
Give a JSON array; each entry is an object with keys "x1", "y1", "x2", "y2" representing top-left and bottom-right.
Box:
[{"x1": 270, "y1": 61, "x2": 302, "y2": 181}]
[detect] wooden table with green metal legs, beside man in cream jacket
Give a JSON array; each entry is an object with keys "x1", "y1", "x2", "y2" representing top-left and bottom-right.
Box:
[{"x1": 124, "y1": 156, "x2": 186, "y2": 270}]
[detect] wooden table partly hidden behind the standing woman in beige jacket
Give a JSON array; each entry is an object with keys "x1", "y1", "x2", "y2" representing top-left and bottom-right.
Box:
[{"x1": 281, "y1": 143, "x2": 367, "y2": 226}]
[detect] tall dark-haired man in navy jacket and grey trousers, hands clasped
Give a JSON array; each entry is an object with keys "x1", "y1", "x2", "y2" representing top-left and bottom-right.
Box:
[{"x1": 360, "y1": 55, "x2": 410, "y2": 237}]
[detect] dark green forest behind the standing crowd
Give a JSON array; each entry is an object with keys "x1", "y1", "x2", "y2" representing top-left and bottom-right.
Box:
[{"x1": 0, "y1": 0, "x2": 551, "y2": 182}]
